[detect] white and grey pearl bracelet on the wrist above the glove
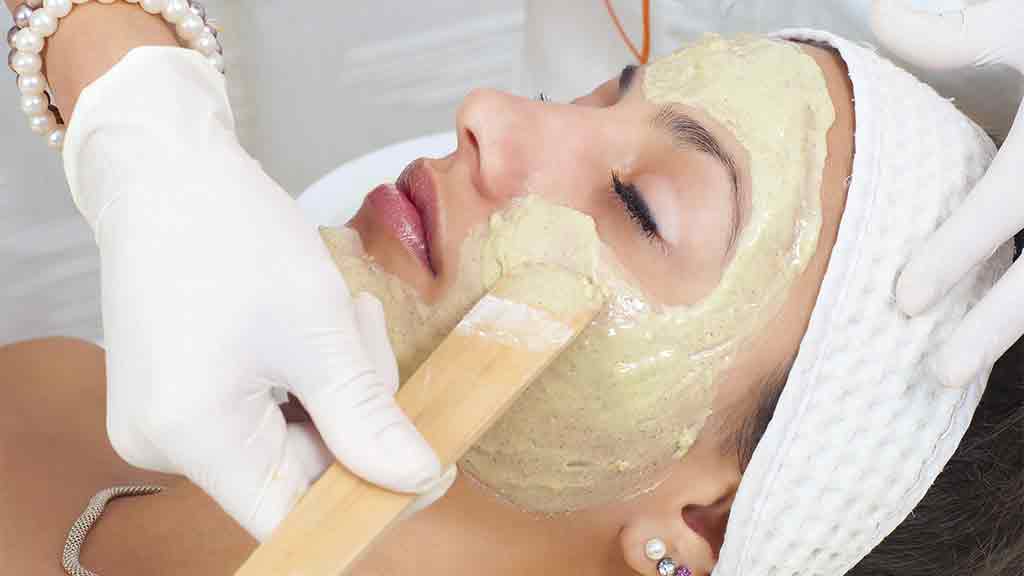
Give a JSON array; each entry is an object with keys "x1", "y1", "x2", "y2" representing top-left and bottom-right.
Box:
[{"x1": 7, "y1": 0, "x2": 224, "y2": 150}]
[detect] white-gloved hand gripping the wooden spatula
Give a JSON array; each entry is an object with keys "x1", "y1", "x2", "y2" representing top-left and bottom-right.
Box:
[{"x1": 63, "y1": 47, "x2": 454, "y2": 539}]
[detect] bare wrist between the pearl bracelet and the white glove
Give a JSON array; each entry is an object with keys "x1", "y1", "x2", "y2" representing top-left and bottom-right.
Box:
[{"x1": 4, "y1": 0, "x2": 178, "y2": 121}]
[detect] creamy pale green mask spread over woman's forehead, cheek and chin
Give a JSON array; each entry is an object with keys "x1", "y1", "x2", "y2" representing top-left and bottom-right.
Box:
[{"x1": 324, "y1": 37, "x2": 835, "y2": 512}]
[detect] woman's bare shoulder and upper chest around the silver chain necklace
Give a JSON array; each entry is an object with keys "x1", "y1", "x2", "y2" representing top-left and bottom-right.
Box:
[{"x1": 0, "y1": 338, "x2": 256, "y2": 576}]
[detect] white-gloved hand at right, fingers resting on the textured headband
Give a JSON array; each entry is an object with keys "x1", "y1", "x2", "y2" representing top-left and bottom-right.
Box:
[{"x1": 871, "y1": 0, "x2": 1024, "y2": 386}]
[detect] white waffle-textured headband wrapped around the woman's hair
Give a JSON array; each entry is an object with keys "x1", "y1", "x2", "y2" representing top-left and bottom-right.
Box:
[{"x1": 714, "y1": 30, "x2": 1012, "y2": 576}]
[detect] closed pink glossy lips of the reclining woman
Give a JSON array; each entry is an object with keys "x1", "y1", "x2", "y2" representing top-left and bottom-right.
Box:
[{"x1": 366, "y1": 160, "x2": 437, "y2": 275}]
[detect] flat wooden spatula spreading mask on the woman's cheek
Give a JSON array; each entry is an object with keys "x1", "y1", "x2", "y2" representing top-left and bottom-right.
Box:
[{"x1": 236, "y1": 265, "x2": 603, "y2": 576}]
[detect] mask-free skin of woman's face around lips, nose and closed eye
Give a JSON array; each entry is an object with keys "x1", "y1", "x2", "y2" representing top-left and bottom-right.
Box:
[{"x1": 351, "y1": 63, "x2": 750, "y2": 303}]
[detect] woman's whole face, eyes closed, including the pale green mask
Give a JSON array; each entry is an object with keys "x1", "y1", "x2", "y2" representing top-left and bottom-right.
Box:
[{"x1": 326, "y1": 36, "x2": 850, "y2": 511}]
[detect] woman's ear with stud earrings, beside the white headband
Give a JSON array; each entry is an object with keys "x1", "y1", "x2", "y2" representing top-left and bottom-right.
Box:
[{"x1": 620, "y1": 426, "x2": 740, "y2": 576}]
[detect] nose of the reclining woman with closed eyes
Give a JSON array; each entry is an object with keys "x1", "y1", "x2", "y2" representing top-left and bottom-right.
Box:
[{"x1": 456, "y1": 89, "x2": 545, "y2": 200}]
